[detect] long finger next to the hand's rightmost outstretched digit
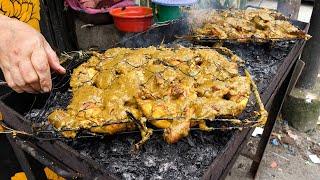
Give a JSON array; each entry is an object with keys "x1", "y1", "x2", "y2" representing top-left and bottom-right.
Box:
[{"x1": 31, "y1": 46, "x2": 52, "y2": 92}]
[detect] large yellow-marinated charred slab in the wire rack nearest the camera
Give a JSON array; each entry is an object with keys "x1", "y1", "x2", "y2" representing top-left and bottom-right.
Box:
[{"x1": 48, "y1": 47, "x2": 264, "y2": 149}]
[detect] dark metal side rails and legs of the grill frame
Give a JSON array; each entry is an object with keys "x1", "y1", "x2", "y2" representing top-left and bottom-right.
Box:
[{"x1": 0, "y1": 19, "x2": 308, "y2": 179}]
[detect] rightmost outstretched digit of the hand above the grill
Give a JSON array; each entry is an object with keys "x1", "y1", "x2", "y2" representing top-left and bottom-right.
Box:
[{"x1": 44, "y1": 40, "x2": 66, "y2": 74}]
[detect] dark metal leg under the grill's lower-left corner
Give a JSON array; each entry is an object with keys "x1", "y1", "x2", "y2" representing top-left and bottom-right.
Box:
[{"x1": 7, "y1": 135, "x2": 47, "y2": 180}]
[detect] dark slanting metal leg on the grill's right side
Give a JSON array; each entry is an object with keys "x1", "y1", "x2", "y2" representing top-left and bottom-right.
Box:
[{"x1": 250, "y1": 60, "x2": 304, "y2": 178}]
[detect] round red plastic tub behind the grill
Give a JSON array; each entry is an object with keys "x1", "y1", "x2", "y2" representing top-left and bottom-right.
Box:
[{"x1": 110, "y1": 6, "x2": 153, "y2": 32}]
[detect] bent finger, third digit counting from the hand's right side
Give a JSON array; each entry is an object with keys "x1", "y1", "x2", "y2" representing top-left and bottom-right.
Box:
[{"x1": 19, "y1": 61, "x2": 41, "y2": 92}]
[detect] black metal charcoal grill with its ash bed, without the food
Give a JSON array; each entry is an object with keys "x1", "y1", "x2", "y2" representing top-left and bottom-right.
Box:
[{"x1": 0, "y1": 21, "x2": 308, "y2": 179}]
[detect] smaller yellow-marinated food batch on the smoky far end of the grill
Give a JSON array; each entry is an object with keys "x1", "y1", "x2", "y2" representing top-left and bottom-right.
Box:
[{"x1": 190, "y1": 9, "x2": 311, "y2": 42}]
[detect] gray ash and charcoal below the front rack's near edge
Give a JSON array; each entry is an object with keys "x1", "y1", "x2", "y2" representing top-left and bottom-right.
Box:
[{"x1": 68, "y1": 131, "x2": 231, "y2": 179}]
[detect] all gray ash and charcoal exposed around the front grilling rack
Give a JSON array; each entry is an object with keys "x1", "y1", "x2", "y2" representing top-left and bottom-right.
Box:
[{"x1": 26, "y1": 42, "x2": 294, "y2": 179}]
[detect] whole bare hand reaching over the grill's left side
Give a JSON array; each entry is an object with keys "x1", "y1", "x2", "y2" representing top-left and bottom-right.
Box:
[{"x1": 0, "y1": 15, "x2": 65, "y2": 93}]
